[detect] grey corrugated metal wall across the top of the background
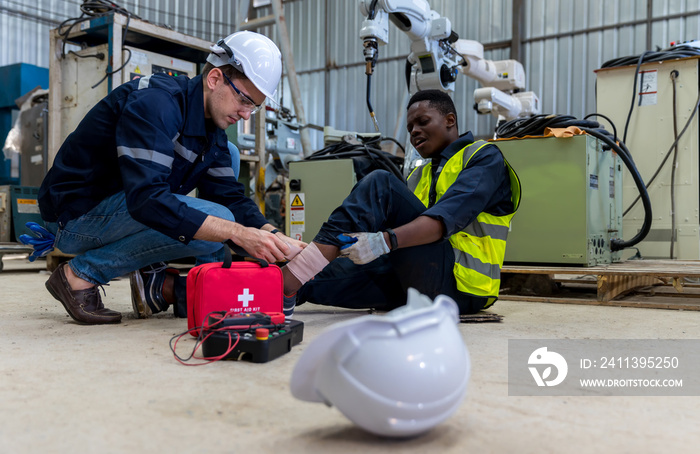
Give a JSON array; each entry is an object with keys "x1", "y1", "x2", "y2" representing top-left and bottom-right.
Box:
[{"x1": 0, "y1": 0, "x2": 700, "y2": 148}]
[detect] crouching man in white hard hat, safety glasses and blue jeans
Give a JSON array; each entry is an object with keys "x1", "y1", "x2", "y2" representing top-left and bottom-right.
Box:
[{"x1": 39, "y1": 31, "x2": 305, "y2": 324}]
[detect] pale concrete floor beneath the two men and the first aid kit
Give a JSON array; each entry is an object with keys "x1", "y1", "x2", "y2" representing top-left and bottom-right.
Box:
[{"x1": 0, "y1": 256, "x2": 700, "y2": 454}]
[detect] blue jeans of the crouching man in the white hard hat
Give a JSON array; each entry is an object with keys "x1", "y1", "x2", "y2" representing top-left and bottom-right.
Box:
[{"x1": 46, "y1": 192, "x2": 228, "y2": 284}]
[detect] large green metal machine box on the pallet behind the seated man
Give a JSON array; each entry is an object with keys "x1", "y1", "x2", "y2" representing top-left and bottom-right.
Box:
[{"x1": 495, "y1": 135, "x2": 623, "y2": 266}]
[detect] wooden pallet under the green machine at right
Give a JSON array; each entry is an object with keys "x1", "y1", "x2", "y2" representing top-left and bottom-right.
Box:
[{"x1": 501, "y1": 260, "x2": 700, "y2": 310}]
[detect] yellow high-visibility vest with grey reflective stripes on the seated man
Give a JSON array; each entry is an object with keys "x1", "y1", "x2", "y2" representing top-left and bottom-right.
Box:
[{"x1": 407, "y1": 140, "x2": 520, "y2": 307}]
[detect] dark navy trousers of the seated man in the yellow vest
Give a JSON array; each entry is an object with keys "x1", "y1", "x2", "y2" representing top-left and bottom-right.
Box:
[{"x1": 297, "y1": 170, "x2": 488, "y2": 314}]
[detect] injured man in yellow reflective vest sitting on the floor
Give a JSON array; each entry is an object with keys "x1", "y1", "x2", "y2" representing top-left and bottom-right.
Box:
[{"x1": 283, "y1": 90, "x2": 520, "y2": 314}]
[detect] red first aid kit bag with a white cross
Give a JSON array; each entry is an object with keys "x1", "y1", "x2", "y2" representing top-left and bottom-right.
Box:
[{"x1": 187, "y1": 245, "x2": 283, "y2": 336}]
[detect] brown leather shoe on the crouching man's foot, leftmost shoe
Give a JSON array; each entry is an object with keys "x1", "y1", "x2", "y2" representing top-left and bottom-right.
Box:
[{"x1": 46, "y1": 262, "x2": 122, "y2": 325}]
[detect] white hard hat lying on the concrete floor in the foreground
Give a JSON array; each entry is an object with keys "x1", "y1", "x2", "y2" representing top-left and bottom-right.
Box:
[{"x1": 291, "y1": 289, "x2": 471, "y2": 437}]
